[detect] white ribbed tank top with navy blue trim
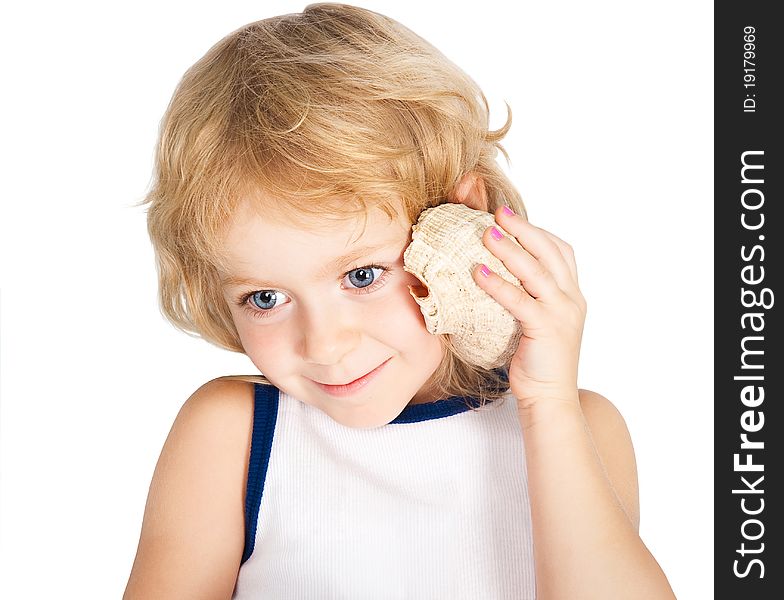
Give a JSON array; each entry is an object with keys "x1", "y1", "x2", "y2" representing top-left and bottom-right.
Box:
[{"x1": 232, "y1": 384, "x2": 536, "y2": 600}]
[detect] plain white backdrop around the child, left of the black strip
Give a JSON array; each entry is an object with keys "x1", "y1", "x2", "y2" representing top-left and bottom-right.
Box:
[{"x1": 0, "y1": 0, "x2": 713, "y2": 599}]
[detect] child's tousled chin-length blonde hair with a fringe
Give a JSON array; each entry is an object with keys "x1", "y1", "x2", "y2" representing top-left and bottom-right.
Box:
[{"x1": 144, "y1": 4, "x2": 525, "y2": 403}]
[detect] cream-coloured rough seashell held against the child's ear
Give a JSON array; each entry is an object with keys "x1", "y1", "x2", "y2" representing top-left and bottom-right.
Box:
[{"x1": 403, "y1": 203, "x2": 522, "y2": 369}]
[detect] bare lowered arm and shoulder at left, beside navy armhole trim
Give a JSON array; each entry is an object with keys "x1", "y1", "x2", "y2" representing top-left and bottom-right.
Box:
[{"x1": 123, "y1": 379, "x2": 253, "y2": 600}]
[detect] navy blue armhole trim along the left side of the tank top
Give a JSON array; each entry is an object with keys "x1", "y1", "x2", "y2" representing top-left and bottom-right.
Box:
[{"x1": 240, "y1": 383, "x2": 278, "y2": 564}]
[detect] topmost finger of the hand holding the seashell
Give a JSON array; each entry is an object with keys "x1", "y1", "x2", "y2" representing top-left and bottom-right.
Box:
[{"x1": 495, "y1": 206, "x2": 577, "y2": 293}]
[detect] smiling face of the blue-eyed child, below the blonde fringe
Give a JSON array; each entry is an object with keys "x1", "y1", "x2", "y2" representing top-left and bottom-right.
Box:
[{"x1": 220, "y1": 197, "x2": 444, "y2": 428}]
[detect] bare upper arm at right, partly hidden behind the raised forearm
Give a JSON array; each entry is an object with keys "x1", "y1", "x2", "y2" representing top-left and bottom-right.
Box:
[{"x1": 579, "y1": 389, "x2": 640, "y2": 529}]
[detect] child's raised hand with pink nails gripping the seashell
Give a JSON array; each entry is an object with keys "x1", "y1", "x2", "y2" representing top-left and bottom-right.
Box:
[{"x1": 473, "y1": 207, "x2": 586, "y2": 407}]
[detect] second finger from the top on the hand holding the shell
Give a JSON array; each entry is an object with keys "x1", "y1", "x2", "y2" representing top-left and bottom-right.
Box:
[{"x1": 482, "y1": 227, "x2": 564, "y2": 301}]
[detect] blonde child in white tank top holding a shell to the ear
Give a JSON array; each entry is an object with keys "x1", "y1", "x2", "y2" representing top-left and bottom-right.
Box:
[{"x1": 125, "y1": 4, "x2": 673, "y2": 599}]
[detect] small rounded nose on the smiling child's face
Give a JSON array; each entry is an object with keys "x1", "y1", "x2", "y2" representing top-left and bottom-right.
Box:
[{"x1": 301, "y1": 307, "x2": 361, "y2": 365}]
